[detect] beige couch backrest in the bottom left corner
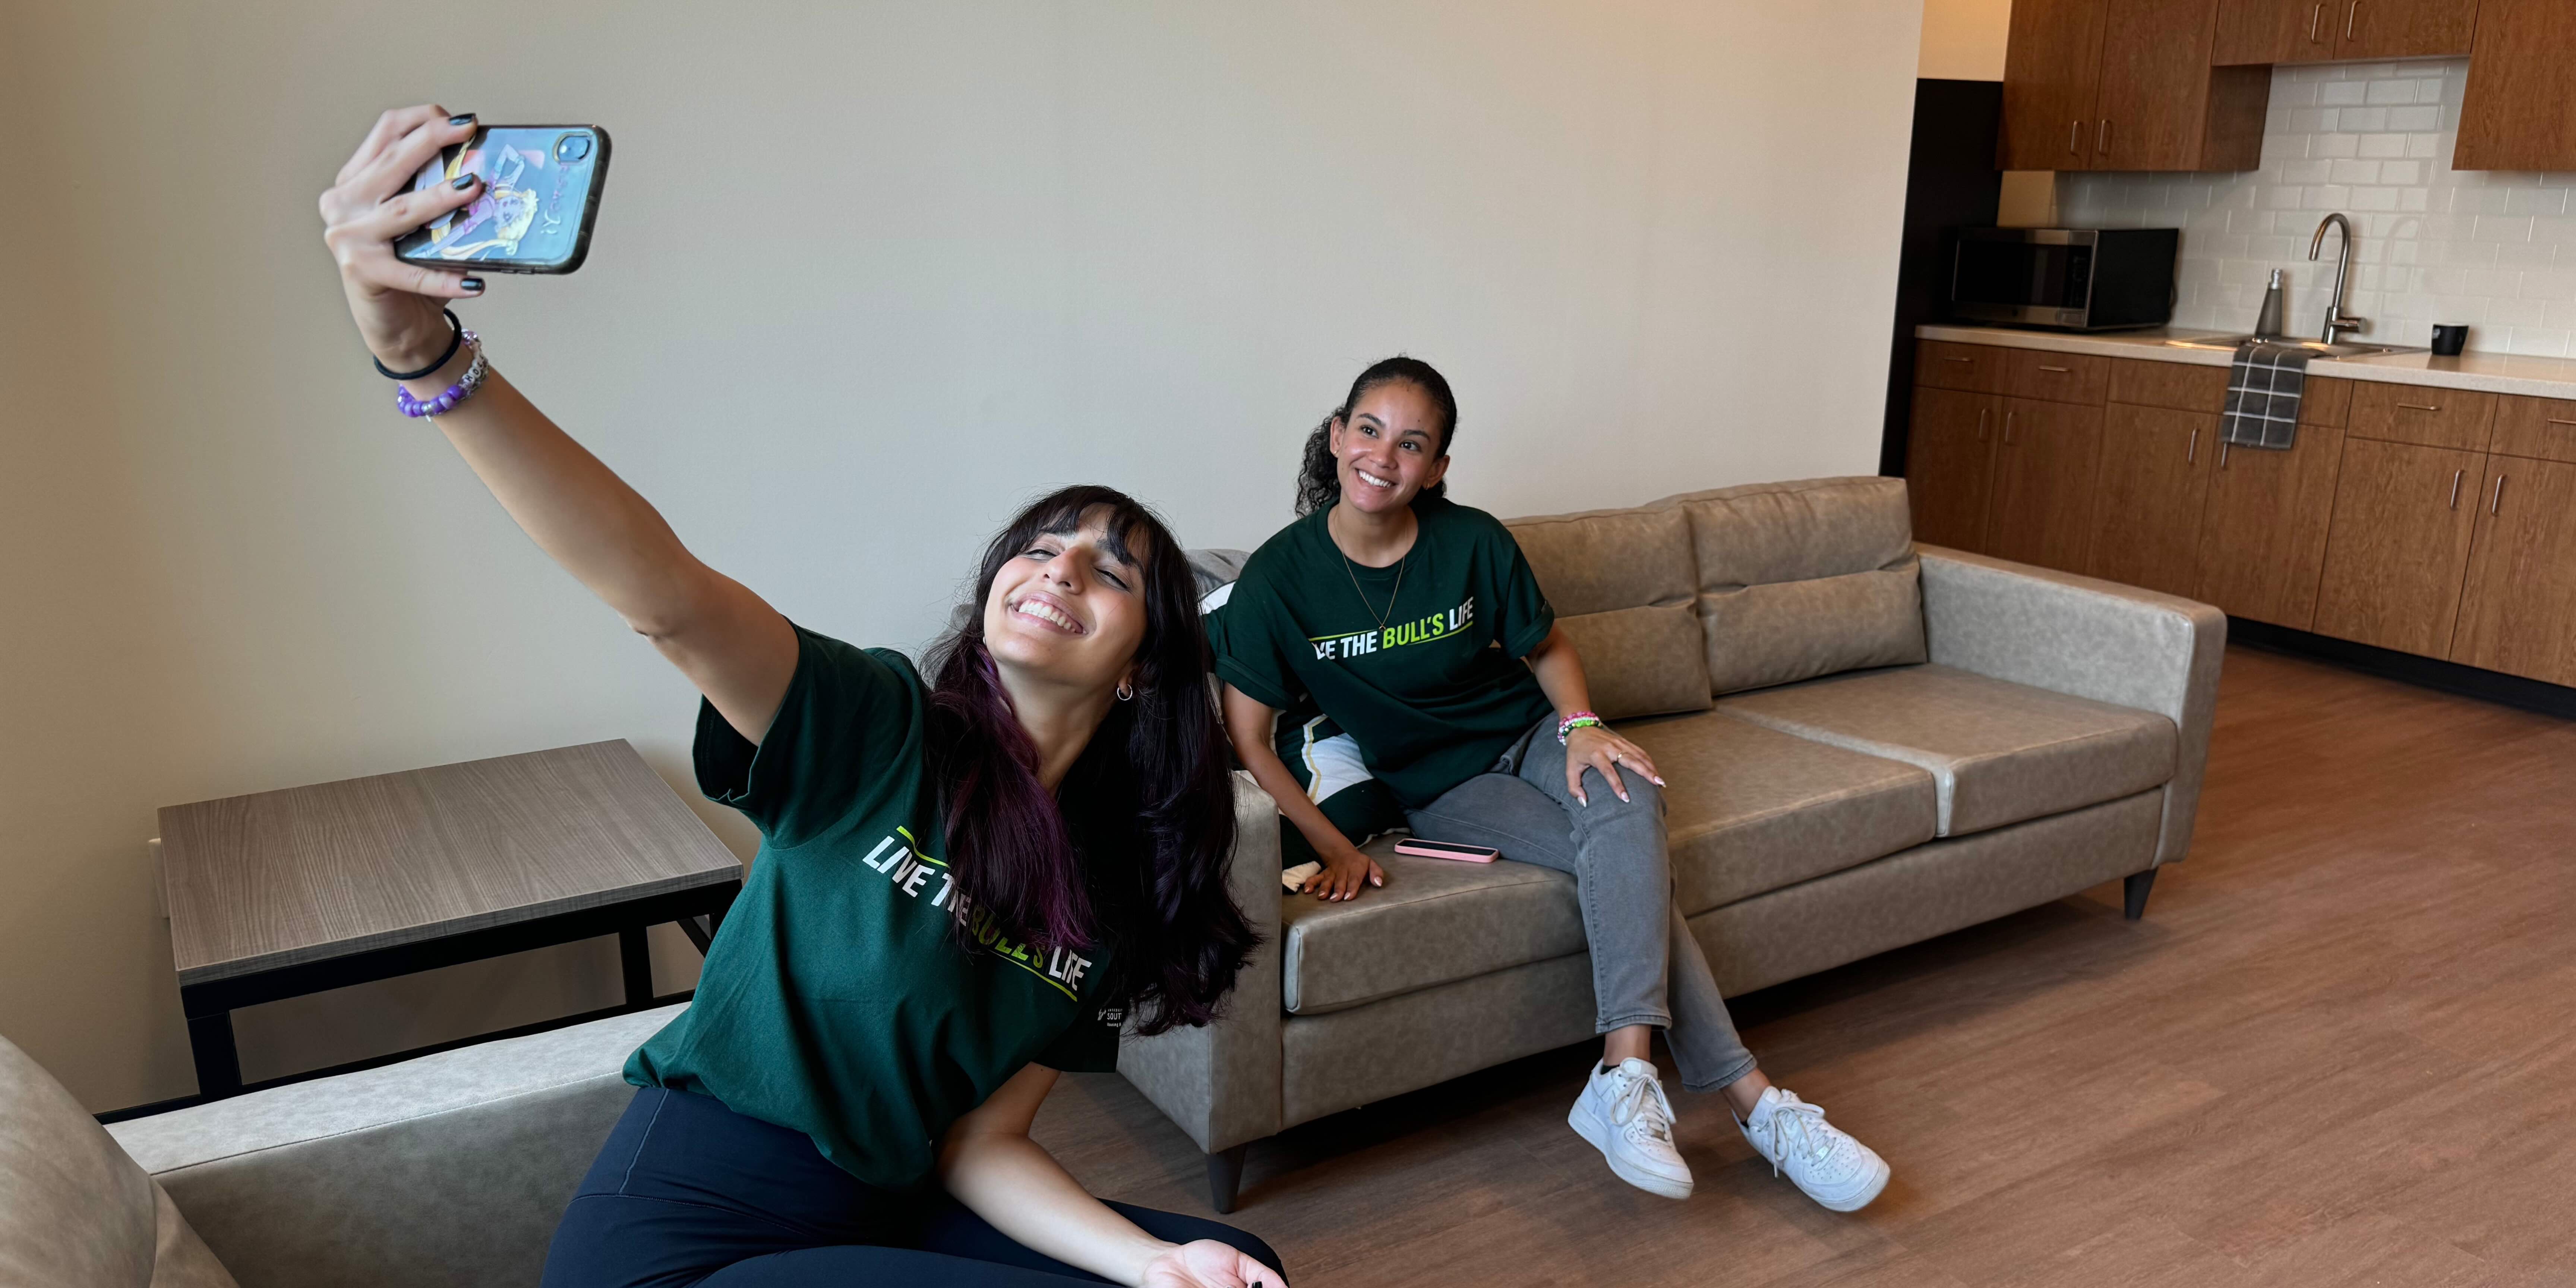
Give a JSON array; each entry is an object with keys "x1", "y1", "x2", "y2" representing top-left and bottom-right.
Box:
[{"x1": 0, "y1": 1038, "x2": 234, "y2": 1288}]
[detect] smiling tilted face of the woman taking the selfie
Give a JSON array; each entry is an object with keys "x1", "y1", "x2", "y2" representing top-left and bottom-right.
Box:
[{"x1": 984, "y1": 505, "x2": 1154, "y2": 693}]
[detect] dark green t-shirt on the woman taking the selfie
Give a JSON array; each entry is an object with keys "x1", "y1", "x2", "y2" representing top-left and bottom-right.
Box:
[{"x1": 626, "y1": 629, "x2": 1126, "y2": 1187}]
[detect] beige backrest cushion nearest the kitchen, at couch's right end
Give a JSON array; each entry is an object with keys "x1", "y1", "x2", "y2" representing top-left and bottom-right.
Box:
[{"x1": 1656, "y1": 479, "x2": 1927, "y2": 693}]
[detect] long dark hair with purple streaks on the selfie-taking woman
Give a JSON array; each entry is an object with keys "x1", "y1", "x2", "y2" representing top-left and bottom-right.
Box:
[{"x1": 930, "y1": 487, "x2": 1254, "y2": 1033}]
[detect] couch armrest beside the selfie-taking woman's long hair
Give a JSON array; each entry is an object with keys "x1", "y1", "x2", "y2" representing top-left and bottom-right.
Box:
[{"x1": 1118, "y1": 770, "x2": 1280, "y2": 1154}]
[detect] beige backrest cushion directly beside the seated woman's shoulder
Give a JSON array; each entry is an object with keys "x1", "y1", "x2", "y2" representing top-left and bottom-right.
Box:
[{"x1": 1505, "y1": 508, "x2": 1711, "y2": 719}]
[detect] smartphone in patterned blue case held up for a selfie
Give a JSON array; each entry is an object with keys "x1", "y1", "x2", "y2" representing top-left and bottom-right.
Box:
[{"x1": 394, "y1": 126, "x2": 608, "y2": 273}]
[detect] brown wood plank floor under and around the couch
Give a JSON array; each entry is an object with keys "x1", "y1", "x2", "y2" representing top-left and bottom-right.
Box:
[{"x1": 1038, "y1": 649, "x2": 2576, "y2": 1288}]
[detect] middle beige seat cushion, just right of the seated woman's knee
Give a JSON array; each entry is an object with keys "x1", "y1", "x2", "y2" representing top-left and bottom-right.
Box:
[{"x1": 1620, "y1": 711, "x2": 1940, "y2": 917}]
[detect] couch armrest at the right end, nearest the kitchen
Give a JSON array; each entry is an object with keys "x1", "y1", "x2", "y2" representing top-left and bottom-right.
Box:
[{"x1": 1917, "y1": 546, "x2": 2228, "y2": 863}]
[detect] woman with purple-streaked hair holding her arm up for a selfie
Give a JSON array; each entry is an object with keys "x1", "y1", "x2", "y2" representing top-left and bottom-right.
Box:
[{"x1": 322, "y1": 105, "x2": 1285, "y2": 1288}]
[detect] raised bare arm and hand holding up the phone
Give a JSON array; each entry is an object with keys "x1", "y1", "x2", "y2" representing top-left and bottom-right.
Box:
[{"x1": 322, "y1": 105, "x2": 796, "y2": 742}]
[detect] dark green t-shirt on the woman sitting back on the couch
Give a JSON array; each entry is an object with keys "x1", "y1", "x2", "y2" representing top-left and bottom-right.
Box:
[{"x1": 1208, "y1": 497, "x2": 1556, "y2": 809}]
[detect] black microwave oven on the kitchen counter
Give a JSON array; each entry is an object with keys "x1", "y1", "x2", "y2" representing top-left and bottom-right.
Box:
[{"x1": 1950, "y1": 229, "x2": 2182, "y2": 330}]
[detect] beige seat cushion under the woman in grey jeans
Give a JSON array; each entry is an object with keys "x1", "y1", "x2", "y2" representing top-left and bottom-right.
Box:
[{"x1": 1280, "y1": 840, "x2": 1576, "y2": 1015}]
